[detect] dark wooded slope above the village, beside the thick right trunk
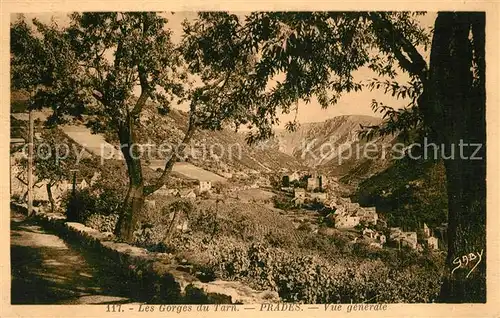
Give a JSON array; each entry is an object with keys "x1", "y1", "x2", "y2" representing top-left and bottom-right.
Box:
[{"x1": 352, "y1": 158, "x2": 448, "y2": 229}]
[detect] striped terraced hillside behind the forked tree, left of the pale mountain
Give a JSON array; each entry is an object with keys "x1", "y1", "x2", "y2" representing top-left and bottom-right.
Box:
[{"x1": 106, "y1": 105, "x2": 303, "y2": 174}]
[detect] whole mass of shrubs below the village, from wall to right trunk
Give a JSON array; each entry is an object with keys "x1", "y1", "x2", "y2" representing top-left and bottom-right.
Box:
[{"x1": 101, "y1": 196, "x2": 444, "y2": 303}]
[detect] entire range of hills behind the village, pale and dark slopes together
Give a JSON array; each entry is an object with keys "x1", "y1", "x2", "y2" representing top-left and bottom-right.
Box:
[{"x1": 12, "y1": 93, "x2": 447, "y2": 232}]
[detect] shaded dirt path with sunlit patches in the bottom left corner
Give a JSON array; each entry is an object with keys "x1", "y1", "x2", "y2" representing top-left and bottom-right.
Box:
[{"x1": 10, "y1": 212, "x2": 138, "y2": 304}]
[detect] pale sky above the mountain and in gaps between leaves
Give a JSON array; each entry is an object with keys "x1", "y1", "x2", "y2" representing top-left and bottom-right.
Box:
[{"x1": 14, "y1": 11, "x2": 436, "y2": 128}]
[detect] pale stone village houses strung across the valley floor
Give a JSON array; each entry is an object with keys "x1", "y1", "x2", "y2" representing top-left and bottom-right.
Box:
[{"x1": 11, "y1": 132, "x2": 446, "y2": 251}]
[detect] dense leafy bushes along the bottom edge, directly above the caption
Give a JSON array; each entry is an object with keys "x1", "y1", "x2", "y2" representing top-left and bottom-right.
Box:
[{"x1": 202, "y1": 238, "x2": 441, "y2": 303}]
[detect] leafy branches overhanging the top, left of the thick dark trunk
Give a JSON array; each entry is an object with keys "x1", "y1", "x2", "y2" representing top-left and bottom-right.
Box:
[{"x1": 184, "y1": 12, "x2": 429, "y2": 142}]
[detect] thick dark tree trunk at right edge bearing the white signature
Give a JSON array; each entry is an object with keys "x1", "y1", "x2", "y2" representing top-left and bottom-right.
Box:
[{"x1": 423, "y1": 12, "x2": 486, "y2": 303}]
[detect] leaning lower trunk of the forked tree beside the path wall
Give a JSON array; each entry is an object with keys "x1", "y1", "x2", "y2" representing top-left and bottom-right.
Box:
[{"x1": 115, "y1": 118, "x2": 144, "y2": 243}]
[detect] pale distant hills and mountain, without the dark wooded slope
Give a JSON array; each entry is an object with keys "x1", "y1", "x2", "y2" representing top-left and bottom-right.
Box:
[{"x1": 10, "y1": 90, "x2": 402, "y2": 185}]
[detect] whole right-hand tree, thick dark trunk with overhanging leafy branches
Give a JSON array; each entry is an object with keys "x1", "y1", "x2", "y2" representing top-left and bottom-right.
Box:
[{"x1": 182, "y1": 12, "x2": 486, "y2": 302}]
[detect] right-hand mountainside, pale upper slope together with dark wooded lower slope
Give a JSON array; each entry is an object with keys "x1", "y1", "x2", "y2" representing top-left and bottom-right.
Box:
[{"x1": 274, "y1": 115, "x2": 447, "y2": 229}]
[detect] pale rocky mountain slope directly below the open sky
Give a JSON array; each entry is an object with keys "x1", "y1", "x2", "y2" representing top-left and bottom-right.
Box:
[{"x1": 275, "y1": 115, "x2": 396, "y2": 184}]
